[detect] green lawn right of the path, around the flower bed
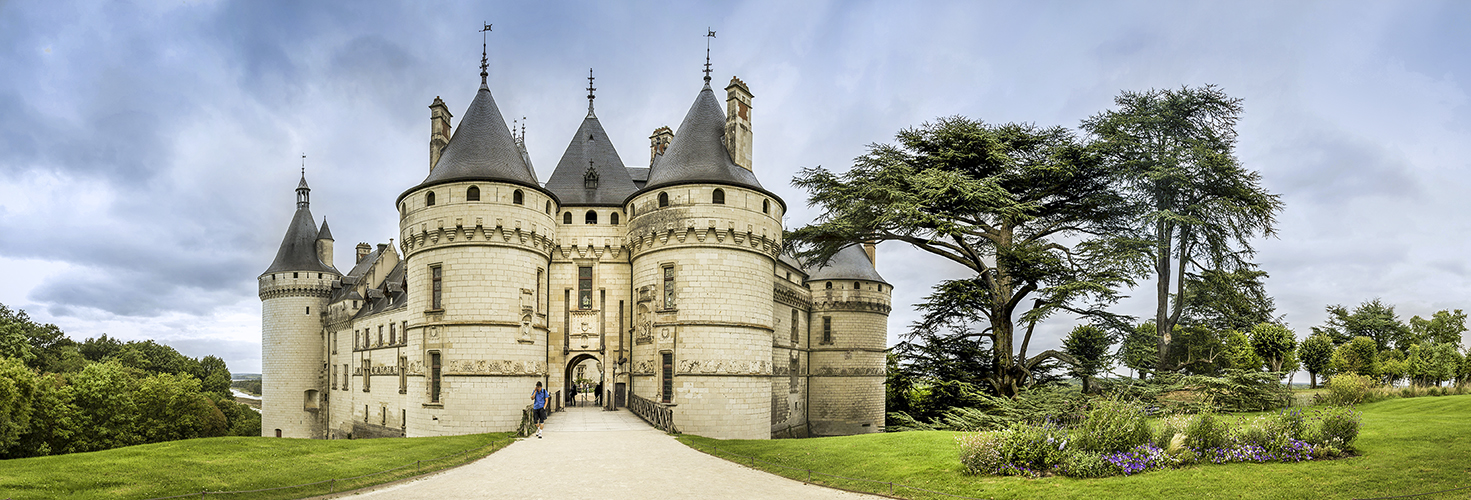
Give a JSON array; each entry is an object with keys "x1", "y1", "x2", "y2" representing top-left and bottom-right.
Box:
[{"x1": 680, "y1": 396, "x2": 1471, "y2": 499}]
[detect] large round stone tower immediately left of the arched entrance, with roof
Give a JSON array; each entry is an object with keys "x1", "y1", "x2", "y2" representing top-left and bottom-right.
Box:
[{"x1": 397, "y1": 72, "x2": 559, "y2": 437}]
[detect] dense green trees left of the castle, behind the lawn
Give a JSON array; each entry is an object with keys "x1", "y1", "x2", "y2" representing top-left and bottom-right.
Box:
[{"x1": 0, "y1": 304, "x2": 260, "y2": 459}]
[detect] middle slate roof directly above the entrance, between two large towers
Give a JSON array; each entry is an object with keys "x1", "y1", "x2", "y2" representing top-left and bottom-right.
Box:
[{"x1": 547, "y1": 112, "x2": 638, "y2": 206}]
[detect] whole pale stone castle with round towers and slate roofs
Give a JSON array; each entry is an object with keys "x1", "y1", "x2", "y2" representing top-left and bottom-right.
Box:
[{"x1": 259, "y1": 52, "x2": 891, "y2": 438}]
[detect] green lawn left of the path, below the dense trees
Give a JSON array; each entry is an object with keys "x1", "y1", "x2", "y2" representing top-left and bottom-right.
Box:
[{"x1": 0, "y1": 432, "x2": 512, "y2": 500}]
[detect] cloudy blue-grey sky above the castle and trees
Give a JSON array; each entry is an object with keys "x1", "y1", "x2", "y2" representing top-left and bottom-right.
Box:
[{"x1": 0, "y1": 0, "x2": 1471, "y2": 372}]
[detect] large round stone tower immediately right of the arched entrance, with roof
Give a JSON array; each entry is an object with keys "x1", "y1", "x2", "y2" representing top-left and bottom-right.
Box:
[{"x1": 625, "y1": 79, "x2": 786, "y2": 440}]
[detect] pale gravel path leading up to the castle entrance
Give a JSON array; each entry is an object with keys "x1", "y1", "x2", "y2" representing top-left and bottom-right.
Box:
[{"x1": 338, "y1": 407, "x2": 878, "y2": 500}]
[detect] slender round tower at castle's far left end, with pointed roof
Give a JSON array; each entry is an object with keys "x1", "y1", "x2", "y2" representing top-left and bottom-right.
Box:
[{"x1": 257, "y1": 174, "x2": 341, "y2": 438}]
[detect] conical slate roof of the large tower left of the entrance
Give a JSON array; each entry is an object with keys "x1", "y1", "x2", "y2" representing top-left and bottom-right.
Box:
[{"x1": 399, "y1": 84, "x2": 540, "y2": 199}]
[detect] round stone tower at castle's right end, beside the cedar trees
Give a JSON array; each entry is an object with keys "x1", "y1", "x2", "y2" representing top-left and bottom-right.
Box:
[{"x1": 808, "y1": 244, "x2": 893, "y2": 435}]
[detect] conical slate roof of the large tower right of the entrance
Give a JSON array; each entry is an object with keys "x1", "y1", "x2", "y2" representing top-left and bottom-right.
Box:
[{"x1": 644, "y1": 82, "x2": 765, "y2": 191}]
